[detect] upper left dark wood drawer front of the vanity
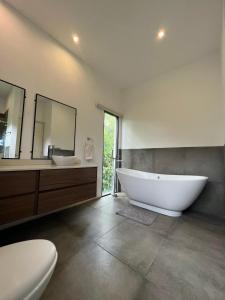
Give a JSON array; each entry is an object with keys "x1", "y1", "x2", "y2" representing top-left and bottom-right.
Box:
[{"x1": 0, "y1": 171, "x2": 36, "y2": 198}]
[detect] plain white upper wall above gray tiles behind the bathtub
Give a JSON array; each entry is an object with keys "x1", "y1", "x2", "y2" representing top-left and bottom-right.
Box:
[{"x1": 122, "y1": 51, "x2": 224, "y2": 149}]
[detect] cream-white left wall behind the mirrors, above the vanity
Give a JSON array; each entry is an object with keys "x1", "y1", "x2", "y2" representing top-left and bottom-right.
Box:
[{"x1": 0, "y1": 2, "x2": 120, "y2": 197}]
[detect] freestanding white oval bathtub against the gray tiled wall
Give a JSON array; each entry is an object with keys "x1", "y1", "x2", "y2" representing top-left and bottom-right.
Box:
[{"x1": 116, "y1": 168, "x2": 208, "y2": 217}]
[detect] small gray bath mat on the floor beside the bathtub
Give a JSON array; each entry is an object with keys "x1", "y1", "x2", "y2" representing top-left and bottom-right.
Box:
[{"x1": 116, "y1": 205, "x2": 157, "y2": 226}]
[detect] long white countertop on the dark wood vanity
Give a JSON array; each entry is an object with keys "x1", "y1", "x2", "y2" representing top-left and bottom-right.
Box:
[{"x1": 0, "y1": 164, "x2": 97, "y2": 172}]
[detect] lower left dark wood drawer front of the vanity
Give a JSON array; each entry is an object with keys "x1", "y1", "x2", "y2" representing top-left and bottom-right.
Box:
[{"x1": 0, "y1": 194, "x2": 35, "y2": 224}]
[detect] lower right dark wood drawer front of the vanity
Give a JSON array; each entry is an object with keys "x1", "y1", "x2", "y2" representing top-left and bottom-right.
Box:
[{"x1": 38, "y1": 183, "x2": 96, "y2": 214}]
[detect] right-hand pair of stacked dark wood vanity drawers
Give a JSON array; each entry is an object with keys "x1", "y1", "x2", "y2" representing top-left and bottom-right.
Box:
[{"x1": 38, "y1": 168, "x2": 97, "y2": 214}]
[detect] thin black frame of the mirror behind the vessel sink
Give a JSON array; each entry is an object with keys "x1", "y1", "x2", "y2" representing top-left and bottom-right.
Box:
[{"x1": 31, "y1": 93, "x2": 77, "y2": 160}]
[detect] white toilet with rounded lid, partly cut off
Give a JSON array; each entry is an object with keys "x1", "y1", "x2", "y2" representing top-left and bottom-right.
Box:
[{"x1": 0, "y1": 240, "x2": 58, "y2": 300}]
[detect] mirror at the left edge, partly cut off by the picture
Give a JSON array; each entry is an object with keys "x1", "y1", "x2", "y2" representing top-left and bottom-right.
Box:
[{"x1": 0, "y1": 80, "x2": 25, "y2": 158}]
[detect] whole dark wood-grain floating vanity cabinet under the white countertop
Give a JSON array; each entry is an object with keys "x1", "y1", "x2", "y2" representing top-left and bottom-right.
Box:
[{"x1": 0, "y1": 167, "x2": 97, "y2": 225}]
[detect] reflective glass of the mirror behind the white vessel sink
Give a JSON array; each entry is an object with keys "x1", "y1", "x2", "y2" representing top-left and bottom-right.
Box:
[{"x1": 32, "y1": 94, "x2": 76, "y2": 159}]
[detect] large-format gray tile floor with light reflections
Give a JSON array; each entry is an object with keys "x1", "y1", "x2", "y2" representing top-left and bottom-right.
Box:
[{"x1": 0, "y1": 196, "x2": 225, "y2": 300}]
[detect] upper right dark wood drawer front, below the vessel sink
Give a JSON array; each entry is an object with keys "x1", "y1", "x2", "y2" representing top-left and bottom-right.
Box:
[{"x1": 39, "y1": 168, "x2": 97, "y2": 191}]
